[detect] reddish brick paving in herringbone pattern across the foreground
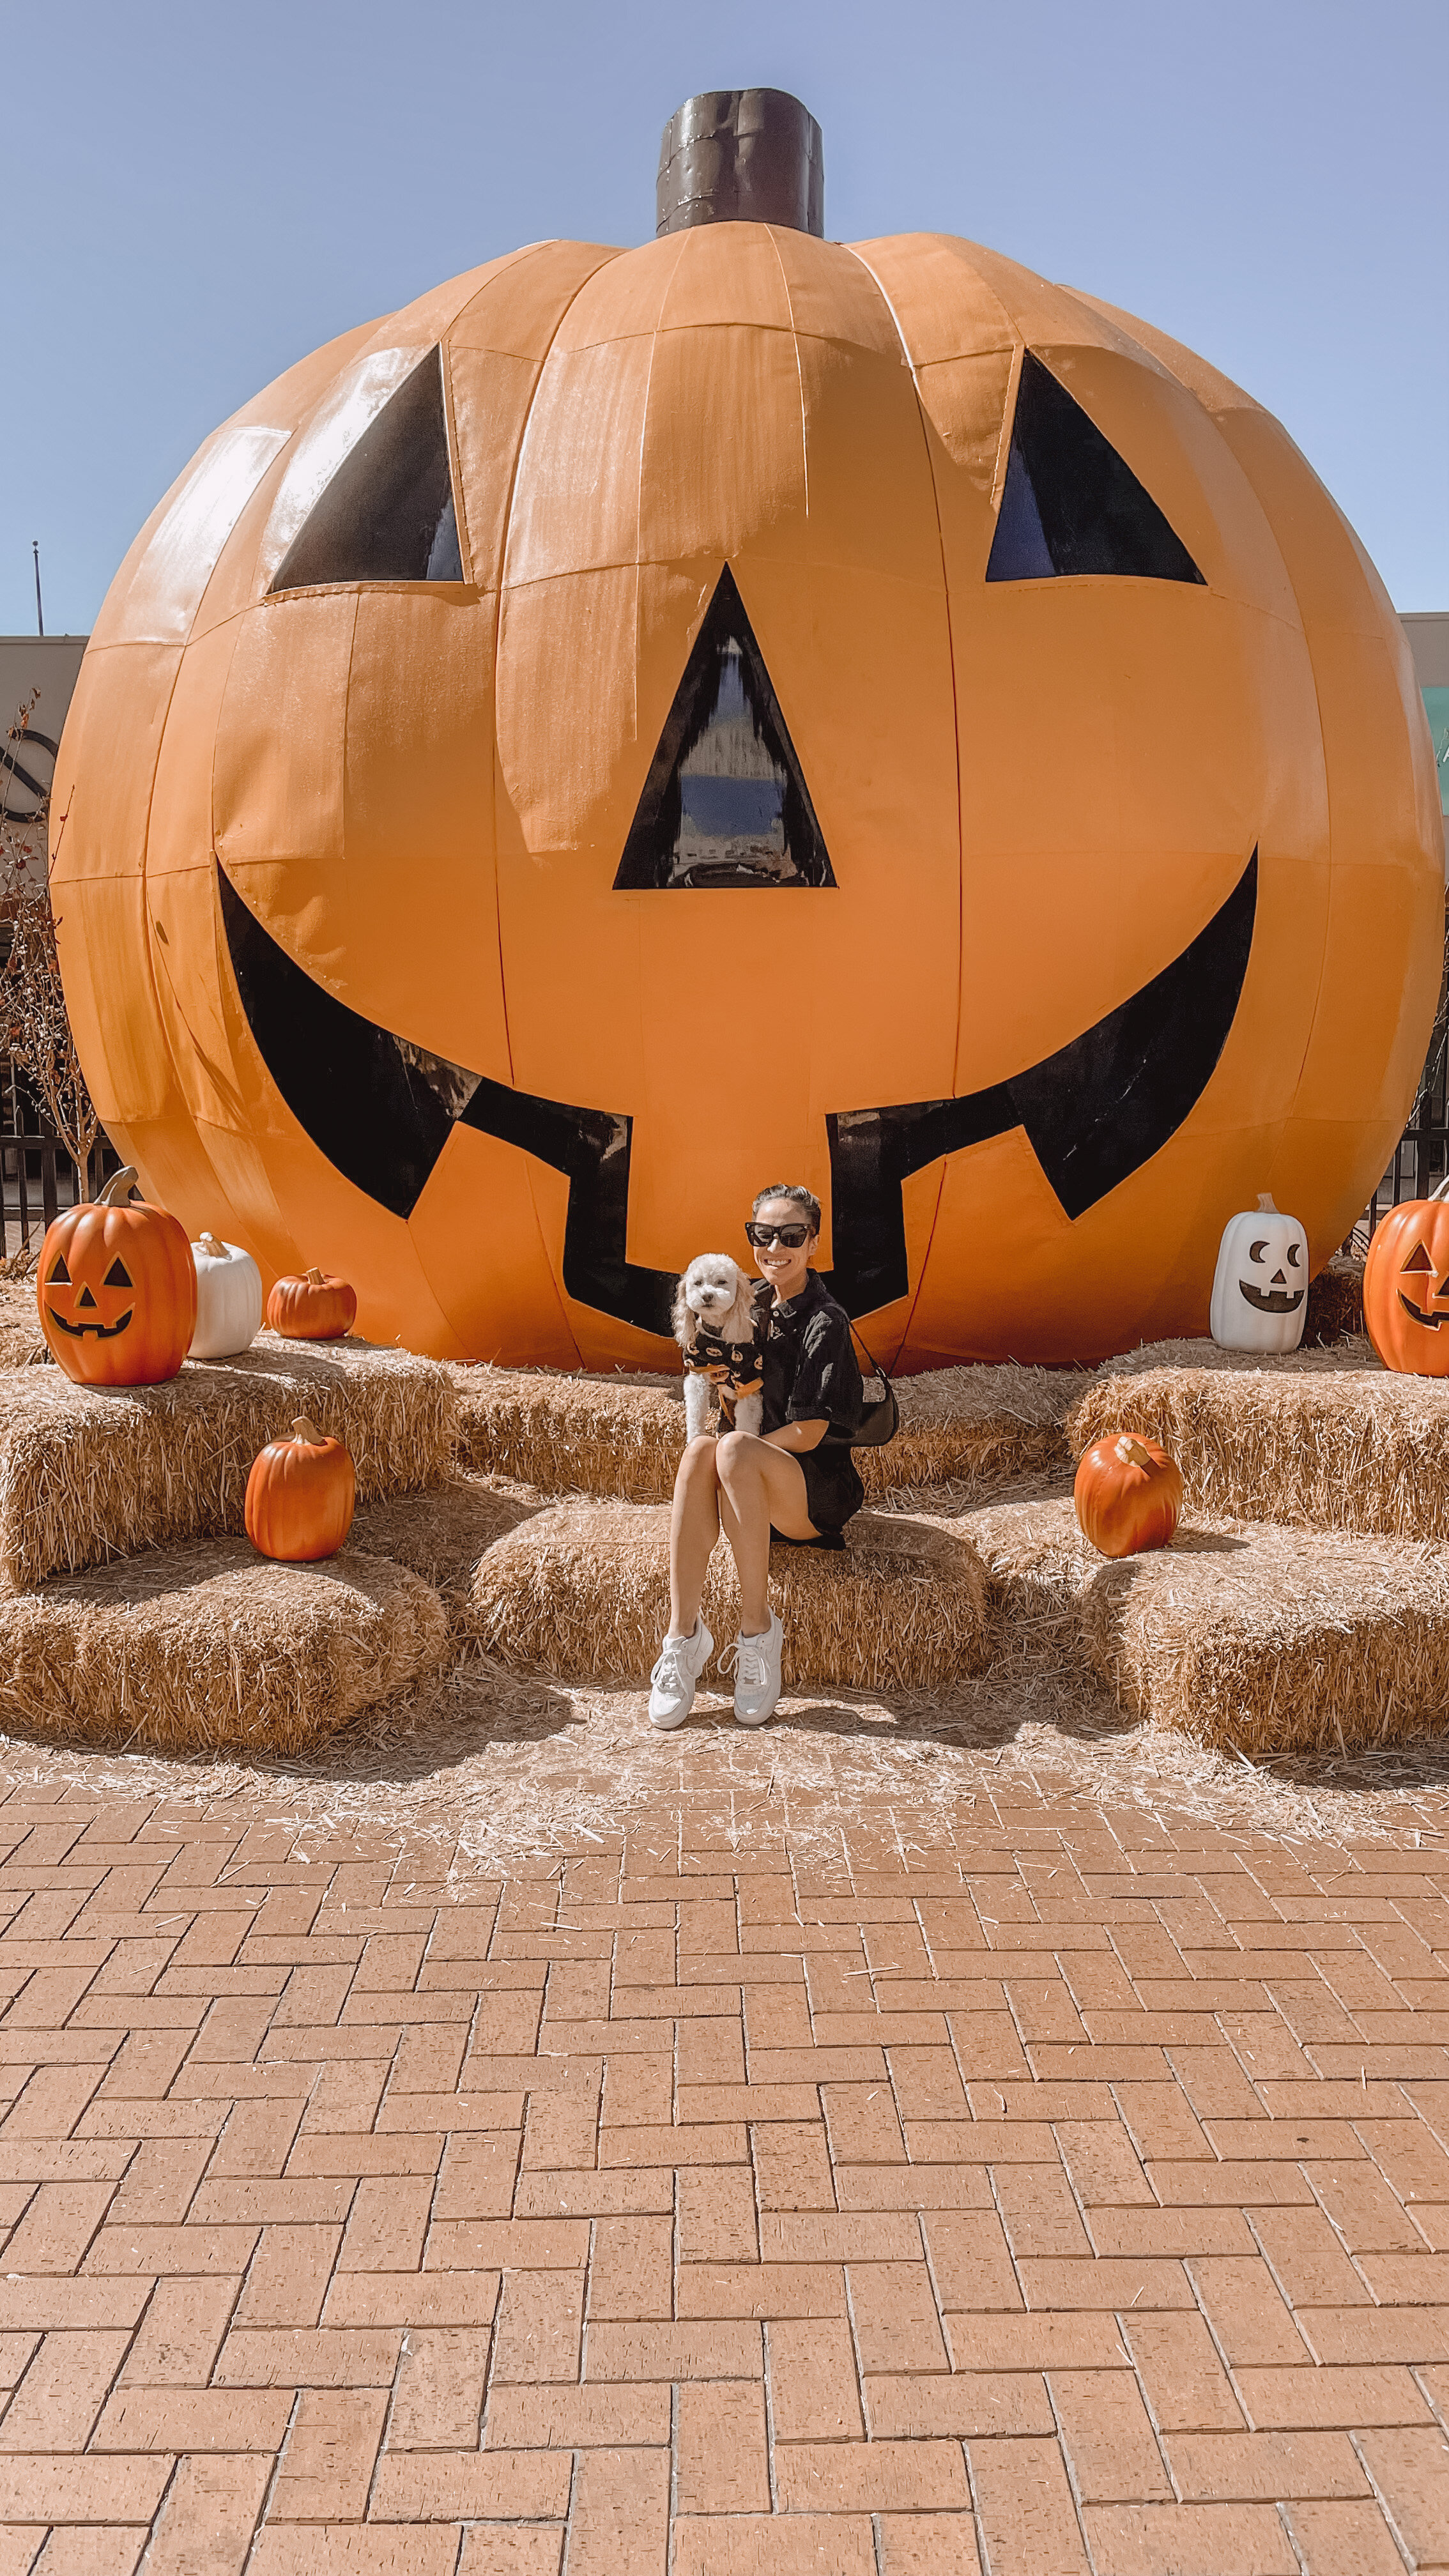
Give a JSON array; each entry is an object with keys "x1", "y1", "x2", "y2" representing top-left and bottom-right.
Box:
[{"x1": 0, "y1": 1754, "x2": 1449, "y2": 2576}]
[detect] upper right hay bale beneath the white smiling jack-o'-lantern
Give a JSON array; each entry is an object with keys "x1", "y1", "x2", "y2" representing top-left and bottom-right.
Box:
[{"x1": 1068, "y1": 1345, "x2": 1449, "y2": 1538}]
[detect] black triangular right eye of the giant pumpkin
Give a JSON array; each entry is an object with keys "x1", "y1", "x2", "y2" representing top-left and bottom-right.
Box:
[{"x1": 985, "y1": 350, "x2": 1202, "y2": 582}]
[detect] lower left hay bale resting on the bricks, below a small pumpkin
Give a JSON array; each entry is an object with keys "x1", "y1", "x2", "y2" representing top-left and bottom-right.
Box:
[{"x1": 0, "y1": 1538, "x2": 448, "y2": 1754}]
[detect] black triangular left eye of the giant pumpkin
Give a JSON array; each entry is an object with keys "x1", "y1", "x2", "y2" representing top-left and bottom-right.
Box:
[{"x1": 271, "y1": 348, "x2": 464, "y2": 590}]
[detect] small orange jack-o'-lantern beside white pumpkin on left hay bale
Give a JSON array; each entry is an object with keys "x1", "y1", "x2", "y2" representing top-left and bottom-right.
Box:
[{"x1": 36, "y1": 1164, "x2": 196, "y2": 1386}]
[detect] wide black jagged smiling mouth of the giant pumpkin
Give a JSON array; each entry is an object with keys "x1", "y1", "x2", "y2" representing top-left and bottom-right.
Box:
[{"x1": 213, "y1": 850, "x2": 1253, "y2": 1337}]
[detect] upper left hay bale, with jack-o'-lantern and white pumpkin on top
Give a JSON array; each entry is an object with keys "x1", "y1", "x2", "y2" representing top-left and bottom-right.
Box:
[{"x1": 0, "y1": 1332, "x2": 456, "y2": 1590}]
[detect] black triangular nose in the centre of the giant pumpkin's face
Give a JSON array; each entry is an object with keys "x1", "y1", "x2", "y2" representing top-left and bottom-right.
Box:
[{"x1": 613, "y1": 564, "x2": 836, "y2": 889}]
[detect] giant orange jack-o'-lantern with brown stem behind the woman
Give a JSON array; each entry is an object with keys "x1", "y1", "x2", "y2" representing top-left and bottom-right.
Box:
[{"x1": 54, "y1": 93, "x2": 1444, "y2": 1368}]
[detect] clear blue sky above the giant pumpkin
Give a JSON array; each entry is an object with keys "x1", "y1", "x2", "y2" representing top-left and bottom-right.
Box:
[{"x1": 0, "y1": 0, "x2": 1449, "y2": 634}]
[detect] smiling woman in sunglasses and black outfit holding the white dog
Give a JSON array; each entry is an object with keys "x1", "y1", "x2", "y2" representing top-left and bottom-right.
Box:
[{"x1": 650, "y1": 1183, "x2": 866, "y2": 1726}]
